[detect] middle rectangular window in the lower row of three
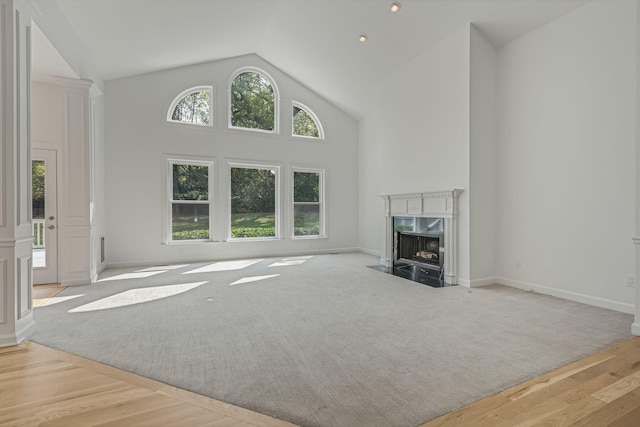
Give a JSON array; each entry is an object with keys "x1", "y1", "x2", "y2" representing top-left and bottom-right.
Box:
[{"x1": 230, "y1": 164, "x2": 280, "y2": 239}]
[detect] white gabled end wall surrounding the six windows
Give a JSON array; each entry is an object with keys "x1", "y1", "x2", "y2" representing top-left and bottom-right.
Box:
[{"x1": 105, "y1": 55, "x2": 358, "y2": 265}]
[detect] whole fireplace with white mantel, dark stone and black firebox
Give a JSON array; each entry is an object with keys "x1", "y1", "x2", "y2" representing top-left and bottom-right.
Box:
[{"x1": 380, "y1": 189, "x2": 462, "y2": 286}]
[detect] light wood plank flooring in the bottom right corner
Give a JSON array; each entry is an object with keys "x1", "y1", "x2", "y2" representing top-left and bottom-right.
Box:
[{"x1": 421, "y1": 337, "x2": 640, "y2": 427}]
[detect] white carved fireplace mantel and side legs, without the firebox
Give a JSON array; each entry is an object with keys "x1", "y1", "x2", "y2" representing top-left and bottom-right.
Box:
[{"x1": 380, "y1": 188, "x2": 463, "y2": 285}]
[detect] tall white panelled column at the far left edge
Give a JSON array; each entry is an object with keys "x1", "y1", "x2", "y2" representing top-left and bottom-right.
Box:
[{"x1": 0, "y1": 0, "x2": 35, "y2": 347}]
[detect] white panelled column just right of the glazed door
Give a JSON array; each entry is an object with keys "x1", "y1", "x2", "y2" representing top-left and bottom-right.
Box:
[{"x1": 56, "y1": 78, "x2": 95, "y2": 285}]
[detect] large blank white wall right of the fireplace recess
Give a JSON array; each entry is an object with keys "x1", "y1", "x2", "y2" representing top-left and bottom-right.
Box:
[{"x1": 497, "y1": 1, "x2": 636, "y2": 312}]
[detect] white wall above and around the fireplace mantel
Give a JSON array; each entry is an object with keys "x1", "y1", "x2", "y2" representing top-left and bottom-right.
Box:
[{"x1": 359, "y1": 27, "x2": 470, "y2": 282}]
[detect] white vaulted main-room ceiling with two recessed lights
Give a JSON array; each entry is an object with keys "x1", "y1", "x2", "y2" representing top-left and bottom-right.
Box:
[{"x1": 41, "y1": 0, "x2": 588, "y2": 118}]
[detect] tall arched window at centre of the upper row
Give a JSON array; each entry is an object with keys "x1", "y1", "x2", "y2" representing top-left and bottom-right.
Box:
[{"x1": 229, "y1": 69, "x2": 278, "y2": 133}]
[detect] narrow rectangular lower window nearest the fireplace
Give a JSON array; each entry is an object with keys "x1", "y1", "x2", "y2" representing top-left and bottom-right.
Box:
[{"x1": 293, "y1": 169, "x2": 324, "y2": 237}]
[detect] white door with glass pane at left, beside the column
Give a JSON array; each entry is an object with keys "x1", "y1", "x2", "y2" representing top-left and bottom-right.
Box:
[{"x1": 31, "y1": 148, "x2": 58, "y2": 285}]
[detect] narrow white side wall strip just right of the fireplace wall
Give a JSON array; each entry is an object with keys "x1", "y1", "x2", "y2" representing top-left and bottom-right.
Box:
[{"x1": 467, "y1": 25, "x2": 497, "y2": 286}]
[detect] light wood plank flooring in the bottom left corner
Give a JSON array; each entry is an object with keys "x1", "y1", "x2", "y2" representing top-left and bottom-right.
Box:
[{"x1": 0, "y1": 342, "x2": 292, "y2": 427}]
